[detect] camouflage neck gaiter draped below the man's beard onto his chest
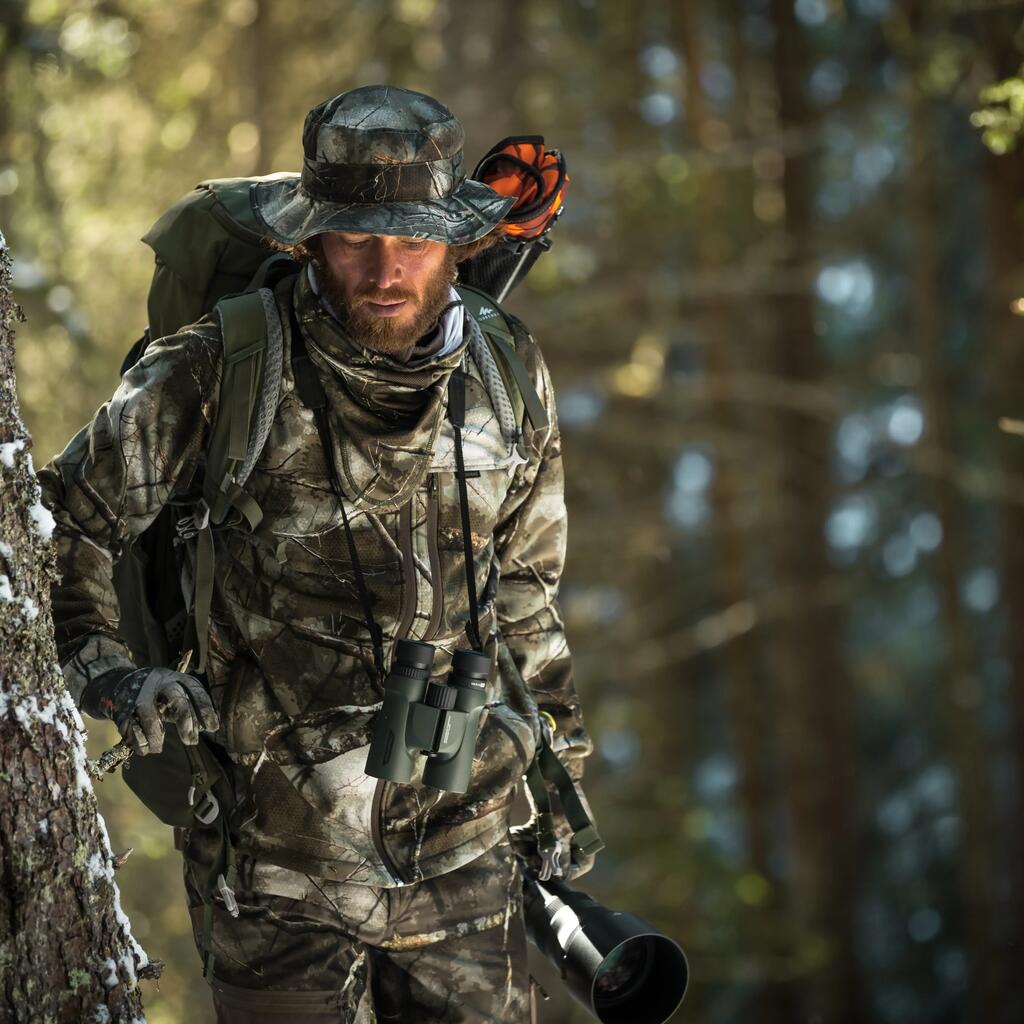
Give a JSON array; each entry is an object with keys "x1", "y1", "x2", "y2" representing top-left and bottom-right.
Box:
[{"x1": 293, "y1": 273, "x2": 467, "y2": 511}]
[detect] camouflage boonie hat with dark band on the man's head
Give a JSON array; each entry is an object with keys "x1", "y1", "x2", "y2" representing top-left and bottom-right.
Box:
[{"x1": 251, "y1": 85, "x2": 515, "y2": 245}]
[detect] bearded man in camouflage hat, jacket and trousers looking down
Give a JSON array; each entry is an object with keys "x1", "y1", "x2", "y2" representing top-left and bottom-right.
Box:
[{"x1": 41, "y1": 86, "x2": 591, "y2": 1024}]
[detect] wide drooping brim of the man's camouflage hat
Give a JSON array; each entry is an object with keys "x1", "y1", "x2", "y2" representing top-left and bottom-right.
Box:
[{"x1": 250, "y1": 174, "x2": 515, "y2": 246}]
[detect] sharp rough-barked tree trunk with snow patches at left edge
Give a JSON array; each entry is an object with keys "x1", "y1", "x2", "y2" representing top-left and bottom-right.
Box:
[{"x1": 0, "y1": 236, "x2": 155, "y2": 1024}]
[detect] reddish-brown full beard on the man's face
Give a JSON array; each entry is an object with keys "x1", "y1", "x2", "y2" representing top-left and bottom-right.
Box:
[{"x1": 317, "y1": 249, "x2": 456, "y2": 359}]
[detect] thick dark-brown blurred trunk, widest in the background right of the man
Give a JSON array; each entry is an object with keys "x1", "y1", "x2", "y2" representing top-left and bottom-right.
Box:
[{"x1": 772, "y1": 0, "x2": 863, "y2": 1024}]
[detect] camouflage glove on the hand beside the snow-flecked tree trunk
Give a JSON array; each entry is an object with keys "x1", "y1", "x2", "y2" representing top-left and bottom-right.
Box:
[{"x1": 82, "y1": 669, "x2": 220, "y2": 755}]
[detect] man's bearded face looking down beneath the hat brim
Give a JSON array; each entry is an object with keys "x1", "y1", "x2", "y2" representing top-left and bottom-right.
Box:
[{"x1": 319, "y1": 231, "x2": 455, "y2": 355}]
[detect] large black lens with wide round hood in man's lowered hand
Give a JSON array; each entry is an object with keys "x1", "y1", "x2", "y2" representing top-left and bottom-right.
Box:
[{"x1": 523, "y1": 871, "x2": 689, "y2": 1024}]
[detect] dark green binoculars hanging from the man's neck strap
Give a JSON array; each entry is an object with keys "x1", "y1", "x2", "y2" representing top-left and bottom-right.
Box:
[{"x1": 366, "y1": 640, "x2": 490, "y2": 793}]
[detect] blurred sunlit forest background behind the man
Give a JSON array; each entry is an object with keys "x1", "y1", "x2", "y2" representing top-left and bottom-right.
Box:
[{"x1": 0, "y1": 0, "x2": 1024, "y2": 1024}]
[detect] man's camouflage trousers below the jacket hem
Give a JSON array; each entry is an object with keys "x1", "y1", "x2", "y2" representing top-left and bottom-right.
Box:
[{"x1": 184, "y1": 830, "x2": 532, "y2": 1024}]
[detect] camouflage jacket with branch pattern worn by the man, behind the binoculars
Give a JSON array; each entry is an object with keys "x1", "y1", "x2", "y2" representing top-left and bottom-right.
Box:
[{"x1": 40, "y1": 274, "x2": 591, "y2": 886}]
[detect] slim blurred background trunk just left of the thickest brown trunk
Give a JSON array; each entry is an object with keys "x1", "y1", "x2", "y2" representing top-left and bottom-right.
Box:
[{"x1": 675, "y1": 3, "x2": 795, "y2": 1024}]
